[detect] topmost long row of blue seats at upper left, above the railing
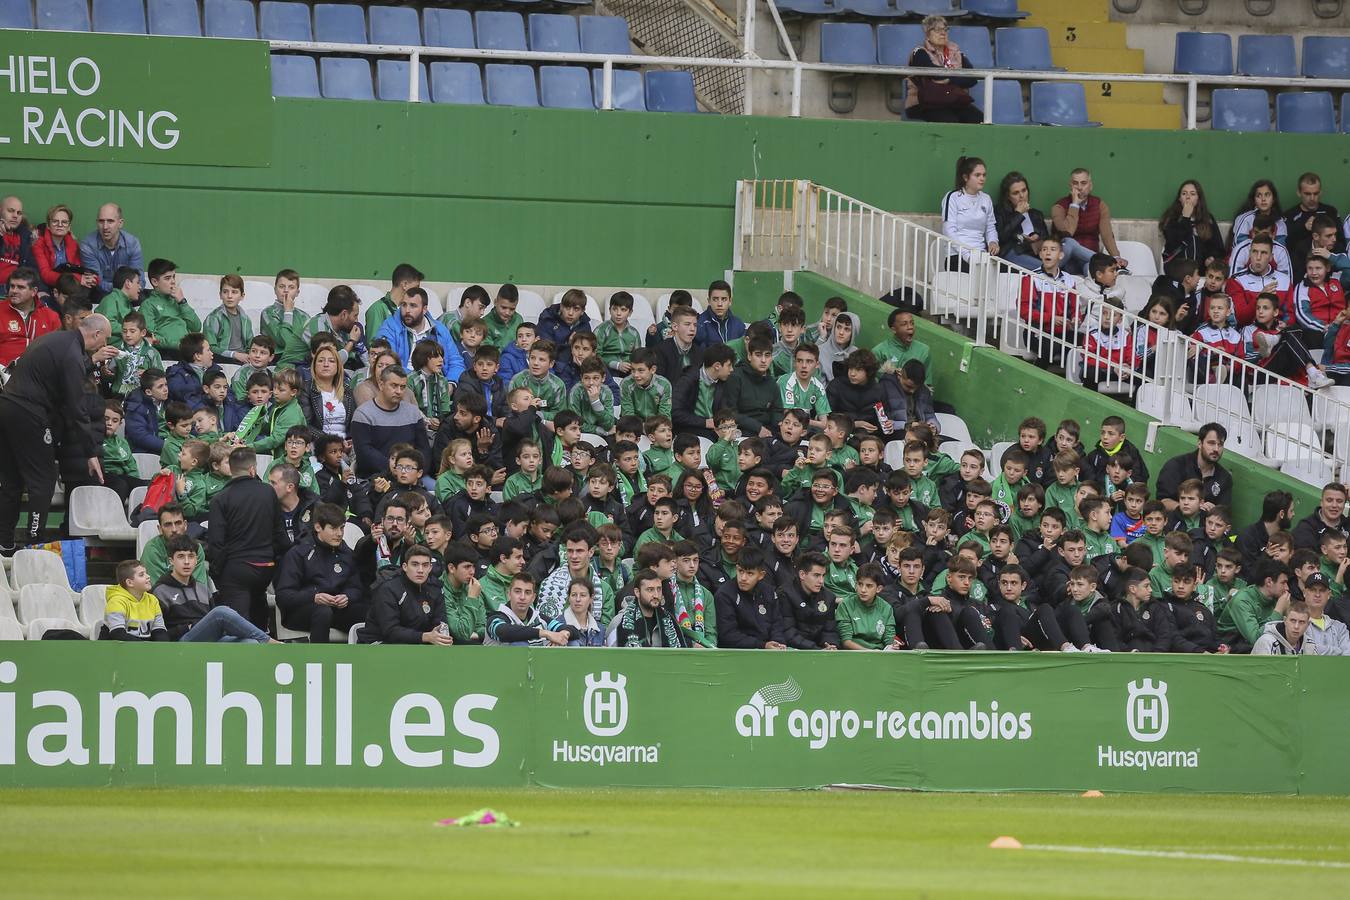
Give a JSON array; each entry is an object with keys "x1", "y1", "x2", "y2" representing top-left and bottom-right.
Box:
[{"x1": 0, "y1": 0, "x2": 621, "y2": 54}]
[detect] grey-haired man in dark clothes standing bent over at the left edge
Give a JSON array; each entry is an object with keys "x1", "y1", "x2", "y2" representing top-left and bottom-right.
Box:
[{"x1": 0, "y1": 314, "x2": 117, "y2": 555}]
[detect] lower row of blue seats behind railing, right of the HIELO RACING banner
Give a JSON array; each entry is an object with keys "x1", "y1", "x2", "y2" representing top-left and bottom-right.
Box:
[{"x1": 271, "y1": 54, "x2": 698, "y2": 112}]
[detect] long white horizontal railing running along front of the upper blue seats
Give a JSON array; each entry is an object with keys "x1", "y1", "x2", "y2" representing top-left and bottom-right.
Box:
[{"x1": 269, "y1": 40, "x2": 1350, "y2": 131}]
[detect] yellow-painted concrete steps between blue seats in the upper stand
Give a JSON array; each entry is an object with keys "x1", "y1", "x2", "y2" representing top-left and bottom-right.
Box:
[{"x1": 1018, "y1": 0, "x2": 1181, "y2": 130}]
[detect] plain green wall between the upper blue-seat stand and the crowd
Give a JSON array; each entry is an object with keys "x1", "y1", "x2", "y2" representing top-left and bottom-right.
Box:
[{"x1": 4, "y1": 100, "x2": 1350, "y2": 286}]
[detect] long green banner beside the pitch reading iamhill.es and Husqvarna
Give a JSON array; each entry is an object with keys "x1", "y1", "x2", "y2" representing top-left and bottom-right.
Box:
[{"x1": 0, "y1": 642, "x2": 1350, "y2": 793}]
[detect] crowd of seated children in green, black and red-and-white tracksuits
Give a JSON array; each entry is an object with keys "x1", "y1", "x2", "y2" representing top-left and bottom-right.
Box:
[{"x1": 0, "y1": 246, "x2": 1323, "y2": 653}]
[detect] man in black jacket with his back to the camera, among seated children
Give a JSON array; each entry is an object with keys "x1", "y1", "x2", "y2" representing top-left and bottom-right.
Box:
[{"x1": 207, "y1": 447, "x2": 285, "y2": 629}]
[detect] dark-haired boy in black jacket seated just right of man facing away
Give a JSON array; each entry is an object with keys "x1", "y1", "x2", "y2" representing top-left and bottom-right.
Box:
[{"x1": 277, "y1": 503, "x2": 370, "y2": 644}]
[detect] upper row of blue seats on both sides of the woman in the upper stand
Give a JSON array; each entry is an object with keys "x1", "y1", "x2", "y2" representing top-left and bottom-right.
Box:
[{"x1": 821, "y1": 22, "x2": 1056, "y2": 72}]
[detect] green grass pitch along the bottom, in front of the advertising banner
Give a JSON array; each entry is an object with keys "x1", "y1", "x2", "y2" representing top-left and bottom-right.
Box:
[{"x1": 0, "y1": 789, "x2": 1350, "y2": 900}]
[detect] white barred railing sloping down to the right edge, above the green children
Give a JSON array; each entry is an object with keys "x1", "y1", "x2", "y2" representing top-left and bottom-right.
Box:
[{"x1": 733, "y1": 181, "x2": 1350, "y2": 483}]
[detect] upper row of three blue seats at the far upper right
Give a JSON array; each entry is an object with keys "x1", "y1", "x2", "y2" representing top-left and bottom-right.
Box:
[{"x1": 1172, "y1": 31, "x2": 1350, "y2": 78}]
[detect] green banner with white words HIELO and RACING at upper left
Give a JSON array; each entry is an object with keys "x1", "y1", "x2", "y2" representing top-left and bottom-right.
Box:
[{"x1": 0, "y1": 30, "x2": 273, "y2": 166}]
